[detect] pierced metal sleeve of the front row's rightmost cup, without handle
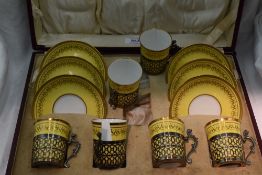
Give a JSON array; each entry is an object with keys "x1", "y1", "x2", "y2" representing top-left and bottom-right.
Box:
[{"x1": 208, "y1": 133, "x2": 245, "y2": 167}]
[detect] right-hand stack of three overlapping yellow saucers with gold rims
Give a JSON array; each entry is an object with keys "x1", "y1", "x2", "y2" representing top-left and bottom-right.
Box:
[{"x1": 166, "y1": 44, "x2": 242, "y2": 119}]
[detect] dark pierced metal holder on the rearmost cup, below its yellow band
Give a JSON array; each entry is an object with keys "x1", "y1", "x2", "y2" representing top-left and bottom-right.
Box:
[{"x1": 140, "y1": 55, "x2": 169, "y2": 75}]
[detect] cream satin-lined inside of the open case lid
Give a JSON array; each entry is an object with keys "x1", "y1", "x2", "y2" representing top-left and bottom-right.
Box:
[{"x1": 28, "y1": 0, "x2": 243, "y2": 50}]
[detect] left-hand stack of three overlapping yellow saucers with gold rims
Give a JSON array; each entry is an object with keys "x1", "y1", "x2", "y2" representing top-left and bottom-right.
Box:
[{"x1": 33, "y1": 41, "x2": 107, "y2": 119}]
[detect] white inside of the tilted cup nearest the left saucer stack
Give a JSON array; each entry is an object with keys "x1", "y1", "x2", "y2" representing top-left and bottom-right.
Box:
[{"x1": 108, "y1": 59, "x2": 143, "y2": 85}]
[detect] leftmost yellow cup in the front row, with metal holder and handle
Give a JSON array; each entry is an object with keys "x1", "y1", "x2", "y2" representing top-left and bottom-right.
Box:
[{"x1": 31, "y1": 118, "x2": 81, "y2": 168}]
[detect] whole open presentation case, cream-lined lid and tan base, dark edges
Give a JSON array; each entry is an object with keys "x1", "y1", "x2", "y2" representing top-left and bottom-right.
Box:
[{"x1": 6, "y1": 0, "x2": 262, "y2": 175}]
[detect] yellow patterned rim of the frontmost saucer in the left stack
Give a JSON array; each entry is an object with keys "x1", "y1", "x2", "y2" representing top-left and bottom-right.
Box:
[{"x1": 33, "y1": 75, "x2": 107, "y2": 119}]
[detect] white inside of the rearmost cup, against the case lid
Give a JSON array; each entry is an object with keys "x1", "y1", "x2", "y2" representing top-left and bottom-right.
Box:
[{"x1": 140, "y1": 28, "x2": 172, "y2": 51}]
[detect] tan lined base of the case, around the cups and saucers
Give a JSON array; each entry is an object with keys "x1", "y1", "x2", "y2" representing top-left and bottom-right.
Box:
[{"x1": 9, "y1": 53, "x2": 262, "y2": 175}]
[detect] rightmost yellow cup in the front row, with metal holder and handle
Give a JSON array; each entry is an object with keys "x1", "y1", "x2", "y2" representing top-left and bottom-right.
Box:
[{"x1": 205, "y1": 118, "x2": 256, "y2": 167}]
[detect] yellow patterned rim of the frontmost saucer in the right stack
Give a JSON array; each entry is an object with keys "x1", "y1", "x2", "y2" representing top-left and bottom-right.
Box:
[{"x1": 169, "y1": 75, "x2": 242, "y2": 119}]
